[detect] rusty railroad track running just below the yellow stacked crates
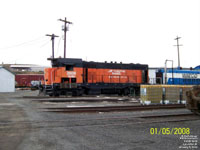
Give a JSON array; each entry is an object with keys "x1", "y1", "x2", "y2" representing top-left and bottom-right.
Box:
[{"x1": 40, "y1": 104, "x2": 185, "y2": 113}]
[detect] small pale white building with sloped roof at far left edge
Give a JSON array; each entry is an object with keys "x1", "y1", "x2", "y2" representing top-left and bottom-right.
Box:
[{"x1": 0, "y1": 66, "x2": 15, "y2": 92}]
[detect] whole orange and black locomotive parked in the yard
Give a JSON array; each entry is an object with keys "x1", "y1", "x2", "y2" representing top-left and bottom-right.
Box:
[{"x1": 44, "y1": 58, "x2": 148, "y2": 96}]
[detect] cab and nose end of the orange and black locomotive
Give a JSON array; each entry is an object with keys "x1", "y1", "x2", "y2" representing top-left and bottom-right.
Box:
[{"x1": 45, "y1": 58, "x2": 83, "y2": 96}]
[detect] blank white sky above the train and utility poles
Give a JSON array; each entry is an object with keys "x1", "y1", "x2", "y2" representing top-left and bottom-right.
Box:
[{"x1": 0, "y1": 0, "x2": 200, "y2": 67}]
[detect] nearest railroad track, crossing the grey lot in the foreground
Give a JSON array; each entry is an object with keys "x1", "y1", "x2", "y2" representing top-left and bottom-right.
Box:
[{"x1": 0, "y1": 113, "x2": 200, "y2": 133}]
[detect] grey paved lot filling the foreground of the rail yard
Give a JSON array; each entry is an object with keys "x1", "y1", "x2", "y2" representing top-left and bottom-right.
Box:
[{"x1": 0, "y1": 91, "x2": 200, "y2": 150}]
